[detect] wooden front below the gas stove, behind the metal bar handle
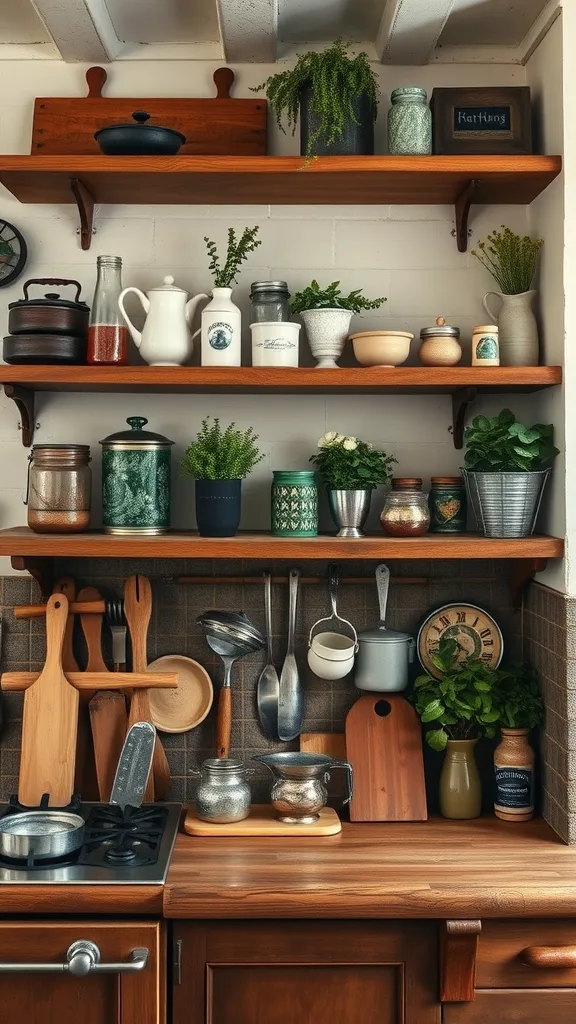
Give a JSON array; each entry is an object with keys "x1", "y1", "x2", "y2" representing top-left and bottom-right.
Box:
[{"x1": 0, "y1": 921, "x2": 166, "y2": 1024}]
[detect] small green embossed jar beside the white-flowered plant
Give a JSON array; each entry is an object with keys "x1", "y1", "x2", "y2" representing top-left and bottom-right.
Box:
[{"x1": 272, "y1": 469, "x2": 318, "y2": 537}]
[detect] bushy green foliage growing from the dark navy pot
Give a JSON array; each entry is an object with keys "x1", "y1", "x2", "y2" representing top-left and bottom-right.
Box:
[{"x1": 180, "y1": 418, "x2": 263, "y2": 480}]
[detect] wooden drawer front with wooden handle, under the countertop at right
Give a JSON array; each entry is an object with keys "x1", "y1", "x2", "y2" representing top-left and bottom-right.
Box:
[{"x1": 476, "y1": 919, "x2": 576, "y2": 987}]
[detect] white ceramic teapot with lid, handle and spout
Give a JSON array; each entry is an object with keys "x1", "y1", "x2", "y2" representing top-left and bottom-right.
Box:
[{"x1": 118, "y1": 276, "x2": 208, "y2": 367}]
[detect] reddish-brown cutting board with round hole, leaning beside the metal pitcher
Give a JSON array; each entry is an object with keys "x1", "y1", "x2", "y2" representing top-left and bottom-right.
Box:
[{"x1": 345, "y1": 693, "x2": 427, "y2": 821}]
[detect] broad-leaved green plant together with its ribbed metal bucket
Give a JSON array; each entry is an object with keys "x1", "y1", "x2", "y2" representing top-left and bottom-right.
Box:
[{"x1": 462, "y1": 409, "x2": 559, "y2": 538}]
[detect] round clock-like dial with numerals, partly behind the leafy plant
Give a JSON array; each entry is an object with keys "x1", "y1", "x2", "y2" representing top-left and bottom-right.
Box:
[{"x1": 418, "y1": 602, "x2": 504, "y2": 679}]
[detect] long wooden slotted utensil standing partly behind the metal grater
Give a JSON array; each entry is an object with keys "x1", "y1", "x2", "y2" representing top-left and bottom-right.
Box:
[{"x1": 124, "y1": 575, "x2": 172, "y2": 802}]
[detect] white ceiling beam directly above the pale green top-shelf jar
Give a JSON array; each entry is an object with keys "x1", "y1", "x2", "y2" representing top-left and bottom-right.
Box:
[{"x1": 376, "y1": 0, "x2": 455, "y2": 65}]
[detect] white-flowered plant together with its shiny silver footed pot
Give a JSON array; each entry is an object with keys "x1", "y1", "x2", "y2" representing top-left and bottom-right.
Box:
[{"x1": 310, "y1": 430, "x2": 396, "y2": 537}]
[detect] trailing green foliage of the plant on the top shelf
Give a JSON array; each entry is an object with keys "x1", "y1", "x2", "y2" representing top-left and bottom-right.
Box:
[{"x1": 252, "y1": 39, "x2": 379, "y2": 157}]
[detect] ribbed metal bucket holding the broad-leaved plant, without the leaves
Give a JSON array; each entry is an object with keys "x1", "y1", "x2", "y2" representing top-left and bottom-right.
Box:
[{"x1": 462, "y1": 469, "x2": 549, "y2": 538}]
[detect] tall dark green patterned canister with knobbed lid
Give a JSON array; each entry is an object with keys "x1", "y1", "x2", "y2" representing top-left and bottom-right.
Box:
[{"x1": 100, "y1": 416, "x2": 174, "y2": 535}]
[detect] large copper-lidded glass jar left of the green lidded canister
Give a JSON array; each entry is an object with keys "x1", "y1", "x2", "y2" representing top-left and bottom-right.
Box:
[{"x1": 25, "y1": 444, "x2": 92, "y2": 534}]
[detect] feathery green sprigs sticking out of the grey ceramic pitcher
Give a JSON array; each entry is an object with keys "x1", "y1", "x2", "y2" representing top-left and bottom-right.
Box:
[{"x1": 472, "y1": 224, "x2": 543, "y2": 295}]
